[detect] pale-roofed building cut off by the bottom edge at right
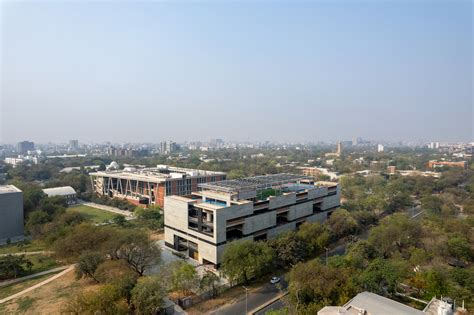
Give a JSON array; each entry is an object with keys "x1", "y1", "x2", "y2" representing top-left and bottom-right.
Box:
[{"x1": 318, "y1": 292, "x2": 465, "y2": 315}]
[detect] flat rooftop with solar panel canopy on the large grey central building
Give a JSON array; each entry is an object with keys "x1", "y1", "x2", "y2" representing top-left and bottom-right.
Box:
[{"x1": 199, "y1": 173, "x2": 314, "y2": 193}]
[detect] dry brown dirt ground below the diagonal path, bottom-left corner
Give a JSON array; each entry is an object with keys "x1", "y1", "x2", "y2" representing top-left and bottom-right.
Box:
[{"x1": 0, "y1": 271, "x2": 95, "y2": 314}]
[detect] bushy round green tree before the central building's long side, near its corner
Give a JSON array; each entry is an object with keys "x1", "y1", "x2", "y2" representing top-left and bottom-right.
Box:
[{"x1": 222, "y1": 240, "x2": 274, "y2": 284}]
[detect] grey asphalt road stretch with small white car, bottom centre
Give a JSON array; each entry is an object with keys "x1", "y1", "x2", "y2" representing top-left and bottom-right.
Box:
[{"x1": 210, "y1": 276, "x2": 288, "y2": 315}]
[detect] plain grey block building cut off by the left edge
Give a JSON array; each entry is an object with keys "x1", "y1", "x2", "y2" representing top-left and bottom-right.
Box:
[{"x1": 0, "y1": 185, "x2": 24, "y2": 244}]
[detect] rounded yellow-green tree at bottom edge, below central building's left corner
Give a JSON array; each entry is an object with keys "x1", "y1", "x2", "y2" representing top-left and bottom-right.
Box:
[{"x1": 132, "y1": 276, "x2": 165, "y2": 315}]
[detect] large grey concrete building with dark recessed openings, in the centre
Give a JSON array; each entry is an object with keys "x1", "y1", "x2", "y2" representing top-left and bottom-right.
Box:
[{"x1": 164, "y1": 174, "x2": 340, "y2": 266}]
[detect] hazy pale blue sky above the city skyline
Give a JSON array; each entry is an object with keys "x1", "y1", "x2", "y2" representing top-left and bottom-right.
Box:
[{"x1": 0, "y1": 0, "x2": 474, "y2": 142}]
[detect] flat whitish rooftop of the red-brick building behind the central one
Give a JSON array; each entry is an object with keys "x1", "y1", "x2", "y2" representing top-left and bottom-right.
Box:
[{"x1": 90, "y1": 165, "x2": 225, "y2": 182}]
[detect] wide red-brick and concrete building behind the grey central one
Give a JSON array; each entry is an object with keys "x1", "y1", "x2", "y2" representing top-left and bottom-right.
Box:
[{"x1": 89, "y1": 165, "x2": 226, "y2": 207}]
